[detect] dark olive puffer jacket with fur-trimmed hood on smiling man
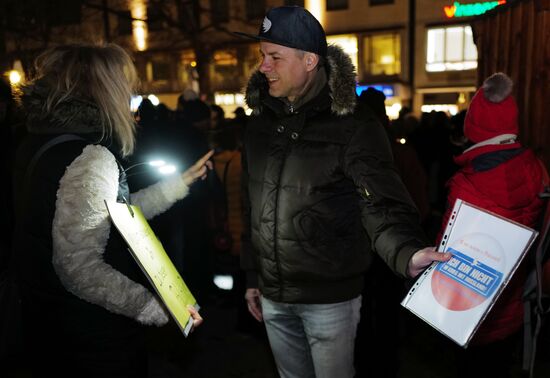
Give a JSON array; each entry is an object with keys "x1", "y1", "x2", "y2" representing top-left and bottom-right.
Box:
[{"x1": 241, "y1": 46, "x2": 426, "y2": 303}]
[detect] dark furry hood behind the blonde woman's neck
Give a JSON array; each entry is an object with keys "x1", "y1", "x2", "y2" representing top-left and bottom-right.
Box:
[{"x1": 20, "y1": 80, "x2": 103, "y2": 134}]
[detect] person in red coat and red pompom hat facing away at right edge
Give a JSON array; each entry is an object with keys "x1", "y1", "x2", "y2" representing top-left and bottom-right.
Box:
[{"x1": 440, "y1": 73, "x2": 544, "y2": 378}]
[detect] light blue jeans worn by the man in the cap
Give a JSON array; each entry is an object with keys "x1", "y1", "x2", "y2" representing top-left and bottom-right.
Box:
[{"x1": 262, "y1": 296, "x2": 361, "y2": 378}]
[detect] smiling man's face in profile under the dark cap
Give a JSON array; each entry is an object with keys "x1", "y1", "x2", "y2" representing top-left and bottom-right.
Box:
[{"x1": 260, "y1": 42, "x2": 311, "y2": 101}]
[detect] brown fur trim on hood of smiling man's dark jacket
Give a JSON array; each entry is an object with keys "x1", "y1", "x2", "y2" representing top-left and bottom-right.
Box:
[{"x1": 245, "y1": 45, "x2": 357, "y2": 115}]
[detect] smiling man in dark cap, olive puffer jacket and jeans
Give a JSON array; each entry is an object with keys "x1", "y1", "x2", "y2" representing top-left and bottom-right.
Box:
[{"x1": 235, "y1": 7, "x2": 448, "y2": 378}]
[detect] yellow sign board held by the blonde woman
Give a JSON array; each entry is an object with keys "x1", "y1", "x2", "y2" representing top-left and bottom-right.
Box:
[{"x1": 105, "y1": 201, "x2": 199, "y2": 336}]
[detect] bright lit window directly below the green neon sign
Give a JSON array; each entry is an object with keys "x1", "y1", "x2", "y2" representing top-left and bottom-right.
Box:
[{"x1": 426, "y1": 26, "x2": 477, "y2": 72}]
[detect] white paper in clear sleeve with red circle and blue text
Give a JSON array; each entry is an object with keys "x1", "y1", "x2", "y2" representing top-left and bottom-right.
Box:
[{"x1": 401, "y1": 200, "x2": 537, "y2": 347}]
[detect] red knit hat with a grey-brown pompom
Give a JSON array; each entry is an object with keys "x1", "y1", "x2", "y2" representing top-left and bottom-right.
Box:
[{"x1": 464, "y1": 72, "x2": 518, "y2": 143}]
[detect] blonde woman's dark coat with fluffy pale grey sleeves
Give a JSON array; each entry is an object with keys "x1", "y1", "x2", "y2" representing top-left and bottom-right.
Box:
[{"x1": 15, "y1": 83, "x2": 188, "y2": 333}]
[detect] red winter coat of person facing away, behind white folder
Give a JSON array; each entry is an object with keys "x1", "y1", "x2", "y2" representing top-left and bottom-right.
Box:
[{"x1": 441, "y1": 143, "x2": 543, "y2": 344}]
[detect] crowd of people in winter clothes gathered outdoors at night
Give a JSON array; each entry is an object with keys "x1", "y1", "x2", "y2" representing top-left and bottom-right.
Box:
[{"x1": 0, "y1": 6, "x2": 547, "y2": 378}]
